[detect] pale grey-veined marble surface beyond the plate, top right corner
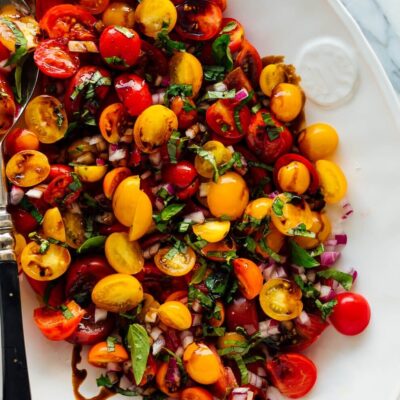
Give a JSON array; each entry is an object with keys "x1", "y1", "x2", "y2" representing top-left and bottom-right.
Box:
[{"x1": 340, "y1": 0, "x2": 400, "y2": 95}]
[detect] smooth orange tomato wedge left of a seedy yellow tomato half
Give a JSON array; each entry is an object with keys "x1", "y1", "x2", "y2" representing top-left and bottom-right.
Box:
[{"x1": 233, "y1": 258, "x2": 264, "y2": 300}]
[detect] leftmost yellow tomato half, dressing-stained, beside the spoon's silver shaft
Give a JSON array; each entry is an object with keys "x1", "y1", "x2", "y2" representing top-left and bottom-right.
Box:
[{"x1": 6, "y1": 150, "x2": 50, "y2": 187}]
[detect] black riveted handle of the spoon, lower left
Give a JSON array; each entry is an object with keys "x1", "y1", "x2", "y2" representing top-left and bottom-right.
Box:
[{"x1": 0, "y1": 260, "x2": 31, "y2": 400}]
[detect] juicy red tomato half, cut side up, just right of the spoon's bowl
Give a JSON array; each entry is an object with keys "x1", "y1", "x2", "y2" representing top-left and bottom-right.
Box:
[{"x1": 33, "y1": 38, "x2": 79, "y2": 79}]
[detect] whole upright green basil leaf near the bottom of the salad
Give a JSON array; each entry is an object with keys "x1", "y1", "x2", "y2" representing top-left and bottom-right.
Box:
[{"x1": 127, "y1": 324, "x2": 150, "y2": 384}]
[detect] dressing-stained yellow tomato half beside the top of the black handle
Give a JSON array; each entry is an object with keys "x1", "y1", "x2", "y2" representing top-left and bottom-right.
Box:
[{"x1": 21, "y1": 242, "x2": 71, "y2": 281}]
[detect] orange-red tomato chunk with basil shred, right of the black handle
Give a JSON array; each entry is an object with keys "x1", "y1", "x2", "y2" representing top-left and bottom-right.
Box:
[{"x1": 33, "y1": 300, "x2": 85, "y2": 340}]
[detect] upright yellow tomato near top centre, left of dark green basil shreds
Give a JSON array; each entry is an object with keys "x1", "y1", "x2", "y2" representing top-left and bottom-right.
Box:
[{"x1": 169, "y1": 52, "x2": 203, "y2": 97}]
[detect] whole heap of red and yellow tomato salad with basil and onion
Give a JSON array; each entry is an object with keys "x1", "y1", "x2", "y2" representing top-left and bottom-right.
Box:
[{"x1": 0, "y1": 0, "x2": 370, "y2": 400}]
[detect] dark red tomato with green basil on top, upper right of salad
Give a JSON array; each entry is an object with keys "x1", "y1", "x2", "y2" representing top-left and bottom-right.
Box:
[{"x1": 246, "y1": 110, "x2": 293, "y2": 164}]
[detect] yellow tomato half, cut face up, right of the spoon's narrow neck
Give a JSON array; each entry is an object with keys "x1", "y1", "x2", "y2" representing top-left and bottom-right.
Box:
[{"x1": 25, "y1": 94, "x2": 68, "y2": 143}]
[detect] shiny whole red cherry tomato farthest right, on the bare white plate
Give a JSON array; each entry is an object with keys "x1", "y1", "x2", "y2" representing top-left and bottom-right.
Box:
[{"x1": 329, "y1": 292, "x2": 371, "y2": 336}]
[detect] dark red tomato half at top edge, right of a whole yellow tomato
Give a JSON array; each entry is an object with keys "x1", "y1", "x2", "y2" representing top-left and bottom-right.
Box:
[{"x1": 175, "y1": 0, "x2": 222, "y2": 41}]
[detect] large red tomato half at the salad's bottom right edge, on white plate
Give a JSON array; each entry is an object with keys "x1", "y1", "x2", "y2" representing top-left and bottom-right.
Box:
[{"x1": 267, "y1": 353, "x2": 317, "y2": 399}]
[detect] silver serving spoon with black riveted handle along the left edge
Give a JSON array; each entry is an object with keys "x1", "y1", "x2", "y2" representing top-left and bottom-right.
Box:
[{"x1": 0, "y1": 0, "x2": 39, "y2": 400}]
